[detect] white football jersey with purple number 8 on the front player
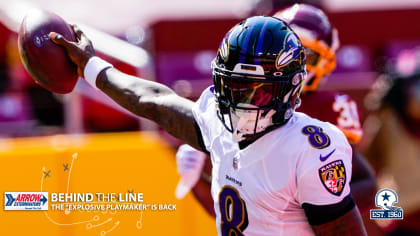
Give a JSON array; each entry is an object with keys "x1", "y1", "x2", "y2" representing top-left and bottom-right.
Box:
[{"x1": 193, "y1": 87, "x2": 352, "y2": 236}]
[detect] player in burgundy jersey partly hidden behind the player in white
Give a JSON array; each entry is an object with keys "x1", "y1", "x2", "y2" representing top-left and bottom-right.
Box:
[{"x1": 177, "y1": 4, "x2": 376, "y2": 217}]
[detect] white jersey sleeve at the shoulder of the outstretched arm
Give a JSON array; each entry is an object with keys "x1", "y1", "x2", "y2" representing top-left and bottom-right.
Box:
[{"x1": 192, "y1": 86, "x2": 217, "y2": 151}]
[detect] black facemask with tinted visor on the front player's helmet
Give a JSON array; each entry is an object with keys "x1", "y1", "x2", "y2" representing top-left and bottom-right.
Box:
[{"x1": 213, "y1": 63, "x2": 305, "y2": 141}]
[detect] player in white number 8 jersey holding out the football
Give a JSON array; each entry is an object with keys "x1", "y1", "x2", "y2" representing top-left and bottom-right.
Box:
[{"x1": 50, "y1": 16, "x2": 366, "y2": 235}]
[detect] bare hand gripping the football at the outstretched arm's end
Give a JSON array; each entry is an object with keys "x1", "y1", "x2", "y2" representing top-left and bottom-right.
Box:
[{"x1": 49, "y1": 25, "x2": 95, "y2": 77}]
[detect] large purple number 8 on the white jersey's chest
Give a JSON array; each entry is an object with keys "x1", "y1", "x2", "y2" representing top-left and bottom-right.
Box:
[{"x1": 219, "y1": 186, "x2": 248, "y2": 236}]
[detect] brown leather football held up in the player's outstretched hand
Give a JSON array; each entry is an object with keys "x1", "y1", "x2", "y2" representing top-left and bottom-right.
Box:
[{"x1": 18, "y1": 9, "x2": 78, "y2": 94}]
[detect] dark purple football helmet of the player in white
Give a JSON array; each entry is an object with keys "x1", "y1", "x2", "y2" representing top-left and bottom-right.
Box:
[{"x1": 212, "y1": 16, "x2": 306, "y2": 140}]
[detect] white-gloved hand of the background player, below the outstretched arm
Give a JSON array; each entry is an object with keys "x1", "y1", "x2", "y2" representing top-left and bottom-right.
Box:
[{"x1": 175, "y1": 144, "x2": 206, "y2": 199}]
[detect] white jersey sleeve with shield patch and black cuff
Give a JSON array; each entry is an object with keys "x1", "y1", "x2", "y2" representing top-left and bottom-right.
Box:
[{"x1": 296, "y1": 125, "x2": 354, "y2": 224}]
